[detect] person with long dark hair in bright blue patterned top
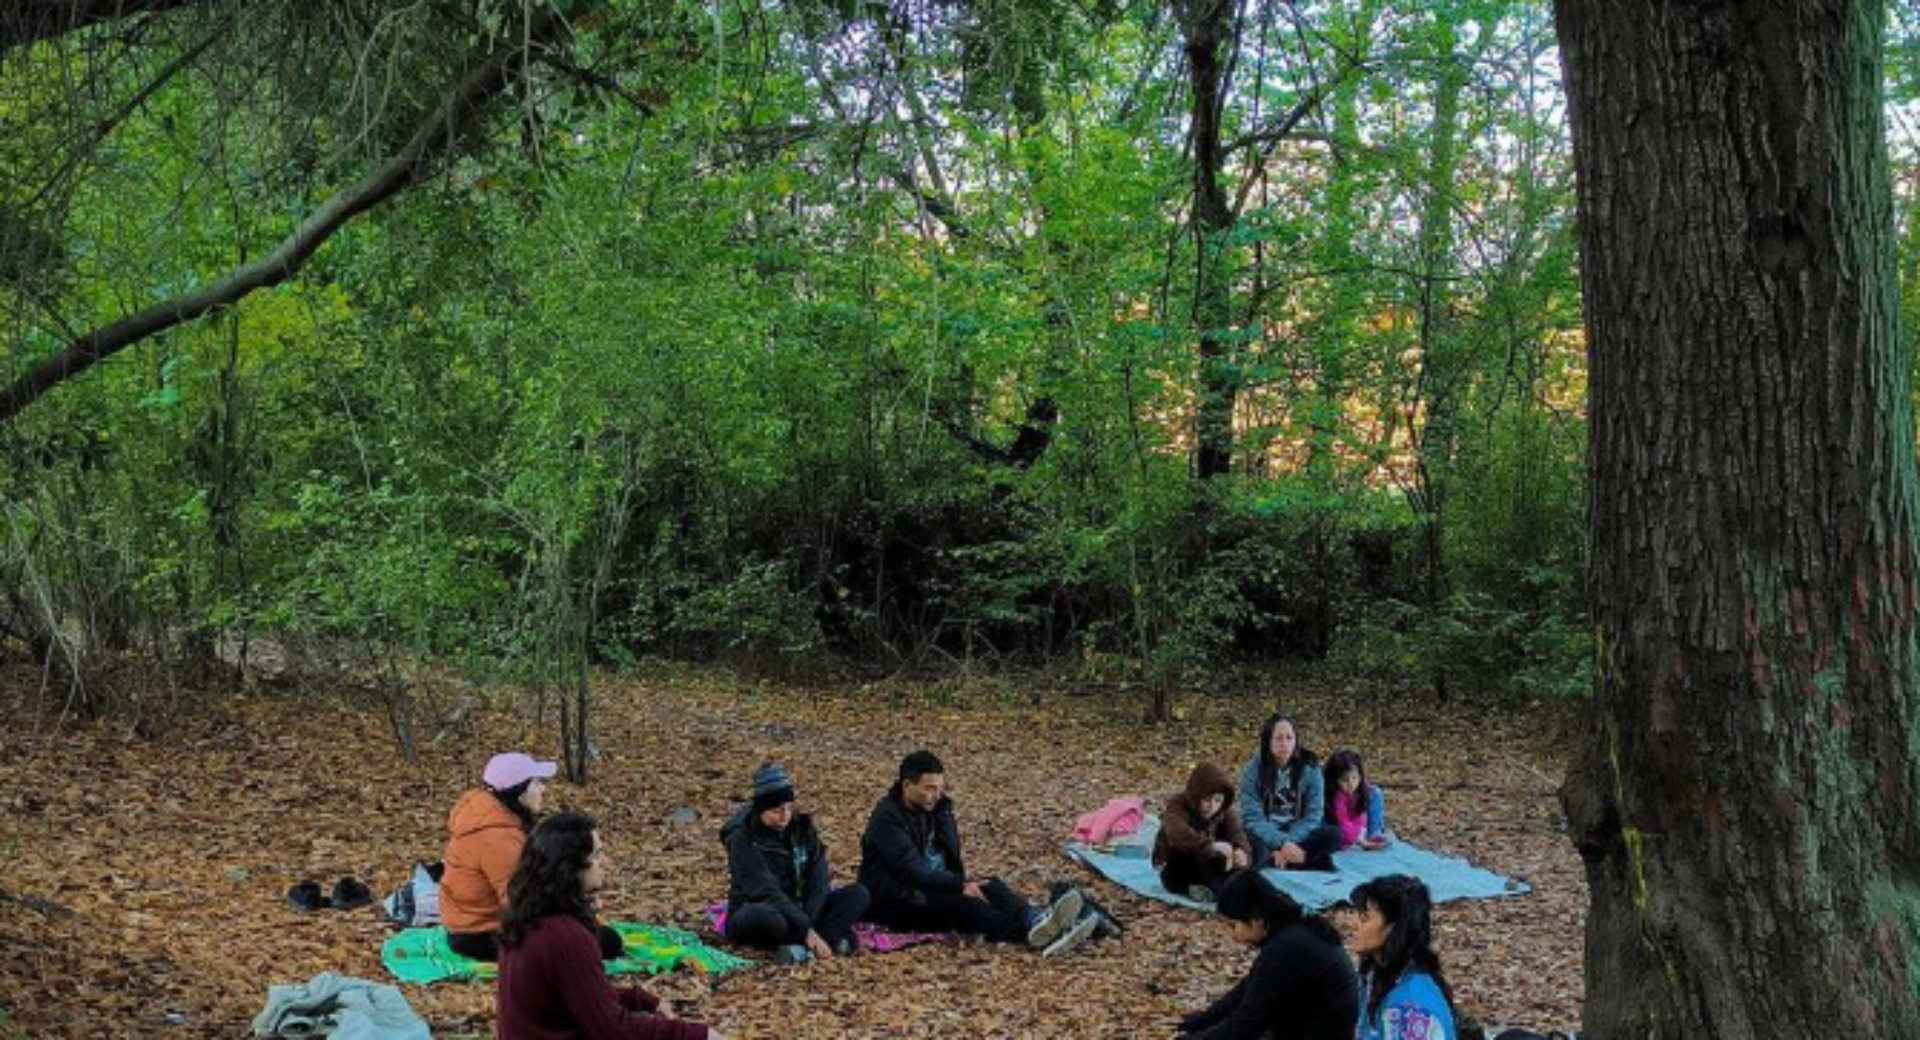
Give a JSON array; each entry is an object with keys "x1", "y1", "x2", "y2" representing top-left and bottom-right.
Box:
[{"x1": 1346, "y1": 873, "x2": 1457, "y2": 1040}]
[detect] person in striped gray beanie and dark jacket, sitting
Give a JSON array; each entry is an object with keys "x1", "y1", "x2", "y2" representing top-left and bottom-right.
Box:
[{"x1": 720, "y1": 762, "x2": 868, "y2": 963}]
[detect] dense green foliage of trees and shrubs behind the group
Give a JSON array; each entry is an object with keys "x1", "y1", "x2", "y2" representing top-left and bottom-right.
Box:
[{"x1": 0, "y1": 0, "x2": 1674, "y2": 721}]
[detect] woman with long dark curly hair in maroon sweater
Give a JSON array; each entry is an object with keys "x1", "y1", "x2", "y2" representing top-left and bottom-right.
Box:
[{"x1": 493, "y1": 812, "x2": 726, "y2": 1040}]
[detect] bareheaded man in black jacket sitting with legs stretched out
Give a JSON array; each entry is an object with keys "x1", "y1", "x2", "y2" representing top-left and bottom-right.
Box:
[{"x1": 860, "y1": 750, "x2": 1100, "y2": 956}]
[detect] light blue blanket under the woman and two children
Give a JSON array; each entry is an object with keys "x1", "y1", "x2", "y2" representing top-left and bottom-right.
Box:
[{"x1": 1066, "y1": 817, "x2": 1530, "y2": 910}]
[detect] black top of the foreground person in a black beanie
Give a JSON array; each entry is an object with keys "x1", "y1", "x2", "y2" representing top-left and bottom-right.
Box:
[{"x1": 1181, "y1": 923, "x2": 1359, "y2": 1040}]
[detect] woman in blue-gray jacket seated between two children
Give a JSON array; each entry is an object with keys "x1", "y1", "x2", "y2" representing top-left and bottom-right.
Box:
[{"x1": 1236, "y1": 712, "x2": 1340, "y2": 871}]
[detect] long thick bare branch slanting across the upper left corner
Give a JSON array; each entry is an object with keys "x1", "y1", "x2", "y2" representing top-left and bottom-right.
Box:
[{"x1": 0, "y1": 12, "x2": 563, "y2": 422}]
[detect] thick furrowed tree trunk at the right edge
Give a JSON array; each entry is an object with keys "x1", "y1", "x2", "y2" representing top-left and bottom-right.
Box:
[{"x1": 1557, "y1": 0, "x2": 1920, "y2": 1040}]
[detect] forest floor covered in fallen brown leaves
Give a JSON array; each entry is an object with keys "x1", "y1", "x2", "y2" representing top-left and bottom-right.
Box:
[{"x1": 0, "y1": 668, "x2": 1586, "y2": 1040}]
